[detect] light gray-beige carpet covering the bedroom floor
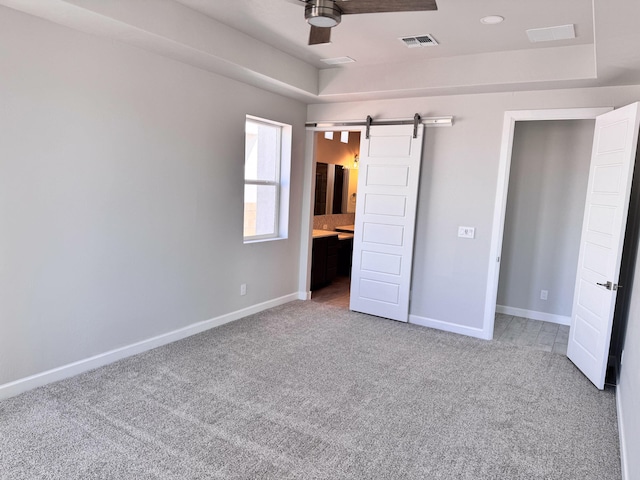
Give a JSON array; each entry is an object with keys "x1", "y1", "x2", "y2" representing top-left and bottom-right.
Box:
[{"x1": 0, "y1": 302, "x2": 621, "y2": 480}]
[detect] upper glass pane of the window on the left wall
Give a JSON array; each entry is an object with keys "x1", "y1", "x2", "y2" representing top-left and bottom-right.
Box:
[{"x1": 244, "y1": 120, "x2": 281, "y2": 182}]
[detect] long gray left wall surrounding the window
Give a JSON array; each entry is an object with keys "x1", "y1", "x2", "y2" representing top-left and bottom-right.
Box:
[{"x1": 0, "y1": 8, "x2": 308, "y2": 385}]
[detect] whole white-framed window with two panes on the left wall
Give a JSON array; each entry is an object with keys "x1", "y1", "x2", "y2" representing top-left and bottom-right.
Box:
[{"x1": 244, "y1": 115, "x2": 291, "y2": 242}]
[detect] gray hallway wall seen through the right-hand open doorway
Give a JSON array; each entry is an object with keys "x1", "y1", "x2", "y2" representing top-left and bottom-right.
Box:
[{"x1": 498, "y1": 120, "x2": 595, "y2": 316}]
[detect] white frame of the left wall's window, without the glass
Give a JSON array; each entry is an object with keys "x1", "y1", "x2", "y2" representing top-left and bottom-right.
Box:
[{"x1": 243, "y1": 115, "x2": 291, "y2": 243}]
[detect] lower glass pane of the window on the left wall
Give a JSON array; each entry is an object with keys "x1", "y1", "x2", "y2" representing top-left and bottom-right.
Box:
[{"x1": 244, "y1": 185, "x2": 278, "y2": 237}]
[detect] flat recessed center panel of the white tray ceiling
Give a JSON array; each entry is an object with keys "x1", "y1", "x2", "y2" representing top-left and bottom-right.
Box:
[{"x1": 172, "y1": 0, "x2": 593, "y2": 68}]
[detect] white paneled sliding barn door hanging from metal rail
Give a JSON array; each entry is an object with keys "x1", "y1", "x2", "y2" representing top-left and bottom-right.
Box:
[{"x1": 350, "y1": 125, "x2": 424, "y2": 322}]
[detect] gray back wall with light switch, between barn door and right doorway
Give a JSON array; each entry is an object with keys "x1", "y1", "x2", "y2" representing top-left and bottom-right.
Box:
[{"x1": 308, "y1": 86, "x2": 640, "y2": 329}]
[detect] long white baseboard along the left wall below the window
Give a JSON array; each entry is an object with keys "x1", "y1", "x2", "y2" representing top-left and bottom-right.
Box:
[{"x1": 0, "y1": 293, "x2": 300, "y2": 400}]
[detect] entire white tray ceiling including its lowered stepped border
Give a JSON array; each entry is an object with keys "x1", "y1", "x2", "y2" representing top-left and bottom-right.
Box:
[{"x1": 0, "y1": 0, "x2": 640, "y2": 103}]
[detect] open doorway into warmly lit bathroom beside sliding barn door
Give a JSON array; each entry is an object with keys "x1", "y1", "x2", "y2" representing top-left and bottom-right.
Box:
[{"x1": 310, "y1": 130, "x2": 361, "y2": 309}]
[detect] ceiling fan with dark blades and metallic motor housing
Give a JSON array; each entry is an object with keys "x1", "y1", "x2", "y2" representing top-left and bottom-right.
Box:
[{"x1": 299, "y1": 0, "x2": 438, "y2": 45}]
